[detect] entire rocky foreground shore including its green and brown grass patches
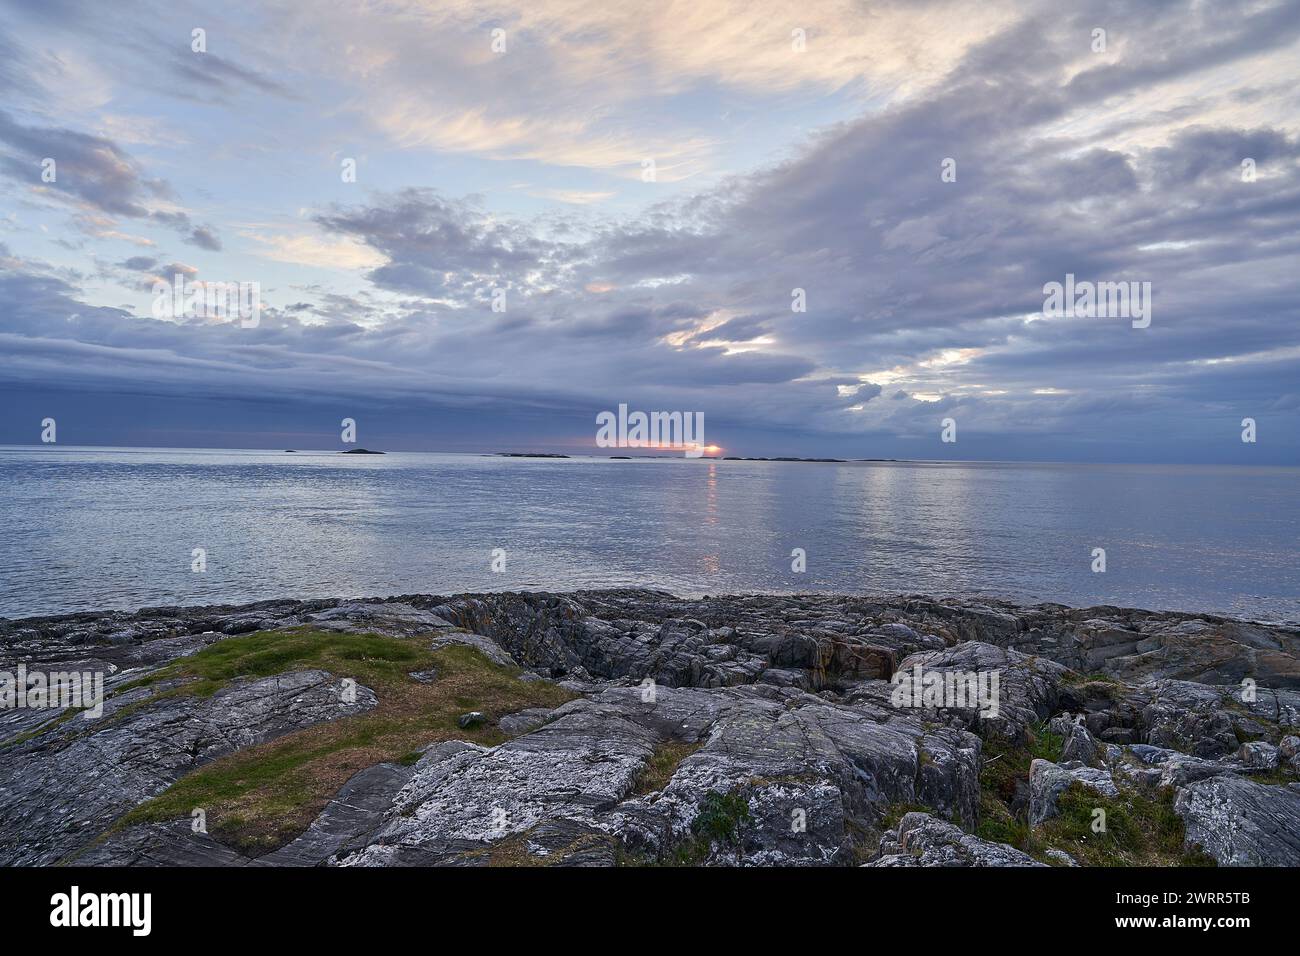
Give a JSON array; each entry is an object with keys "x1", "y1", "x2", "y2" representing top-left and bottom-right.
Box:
[{"x1": 0, "y1": 591, "x2": 1300, "y2": 866}]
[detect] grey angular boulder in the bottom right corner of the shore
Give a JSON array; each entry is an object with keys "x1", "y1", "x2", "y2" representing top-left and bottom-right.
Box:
[{"x1": 1174, "y1": 774, "x2": 1300, "y2": 866}]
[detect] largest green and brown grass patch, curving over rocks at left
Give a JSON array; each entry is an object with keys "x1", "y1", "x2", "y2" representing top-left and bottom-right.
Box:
[{"x1": 114, "y1": 631, "x2": 573, "y2": 855}]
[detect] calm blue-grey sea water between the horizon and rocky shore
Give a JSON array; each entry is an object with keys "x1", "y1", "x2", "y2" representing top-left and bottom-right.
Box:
[{"x1": 0, "y1": 446, "x2": 1300, "y2": 620}]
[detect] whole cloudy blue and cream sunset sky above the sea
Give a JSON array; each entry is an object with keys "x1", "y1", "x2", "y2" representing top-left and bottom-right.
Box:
[{"x1": 0, "y1": 0, "x2": 1300, "y2": 466}]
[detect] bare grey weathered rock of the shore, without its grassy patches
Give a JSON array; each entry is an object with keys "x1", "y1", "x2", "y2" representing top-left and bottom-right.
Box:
[{"x1": 0, "y1": 589, "x2": 1300, "y2": 866}]
